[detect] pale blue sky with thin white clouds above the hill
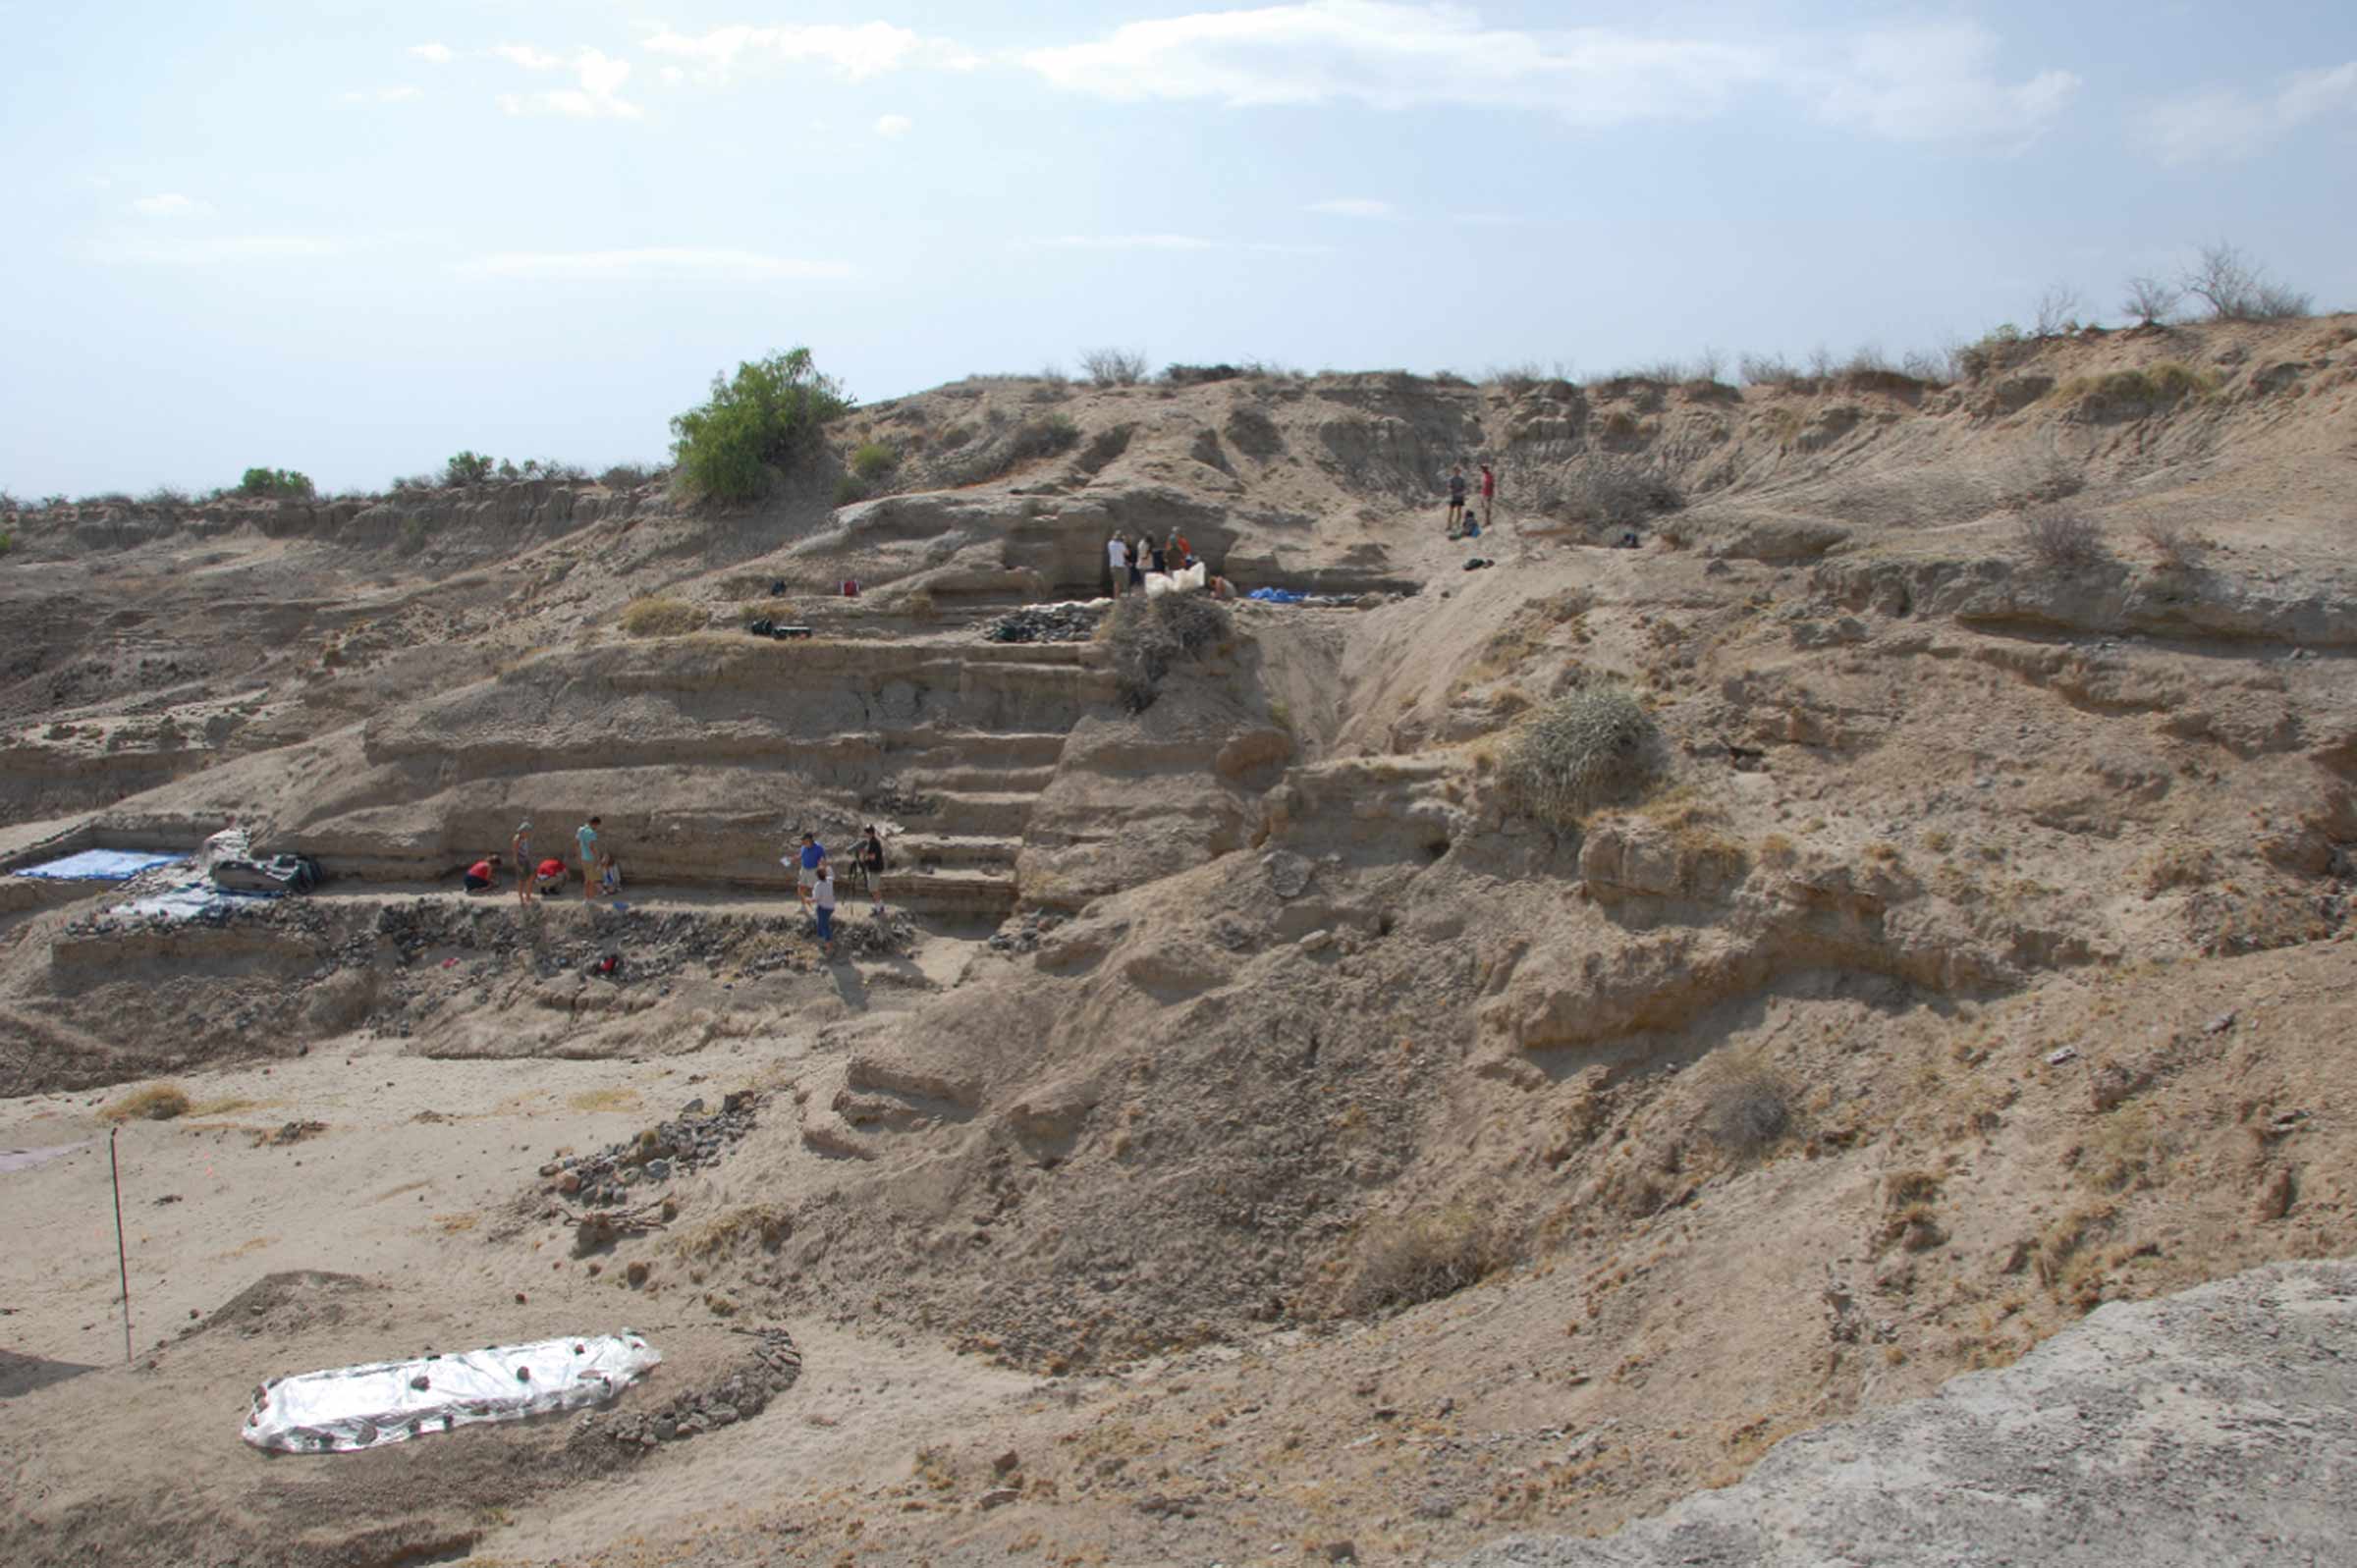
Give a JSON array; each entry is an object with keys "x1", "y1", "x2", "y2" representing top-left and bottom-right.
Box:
[{"x1": 0, "y1": 0, "x2": 2357, "y2": 495}]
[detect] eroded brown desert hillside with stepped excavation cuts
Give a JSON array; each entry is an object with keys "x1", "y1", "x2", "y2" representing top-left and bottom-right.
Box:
[{"x1": 0, "y1": 318, "x2": 2357, "y2": 1563}]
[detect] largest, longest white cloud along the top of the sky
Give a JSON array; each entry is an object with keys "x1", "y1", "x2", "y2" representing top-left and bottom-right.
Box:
[{"x1": 1020, "y1": 0, "x2": 2079, "y2": 136}]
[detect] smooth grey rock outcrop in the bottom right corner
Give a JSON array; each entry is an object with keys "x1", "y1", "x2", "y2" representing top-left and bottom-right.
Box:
[{"x1": 1459, "y1": 1262, "x2": 2357, "y2": 1568}]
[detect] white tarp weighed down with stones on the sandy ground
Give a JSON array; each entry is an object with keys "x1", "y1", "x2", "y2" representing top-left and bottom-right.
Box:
[{"x1": 246, "y1": 1327, "x2": 662, "y2": 1452}]
